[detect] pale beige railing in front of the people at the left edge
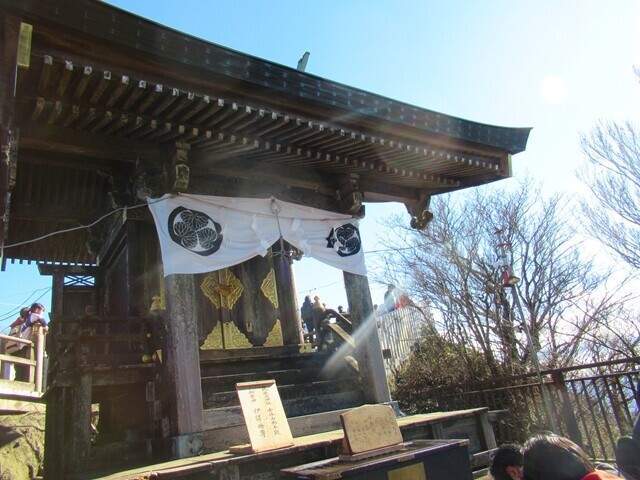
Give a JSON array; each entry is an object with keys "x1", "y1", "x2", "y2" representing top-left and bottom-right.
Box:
[{"x1": 0, "y1": 327, "x2": 45, "y2": 395}]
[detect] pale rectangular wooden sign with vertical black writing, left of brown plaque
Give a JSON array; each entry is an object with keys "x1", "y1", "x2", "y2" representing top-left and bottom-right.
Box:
[{"x1": 236, "y1": 380, "x2": 293, "y2": 453}]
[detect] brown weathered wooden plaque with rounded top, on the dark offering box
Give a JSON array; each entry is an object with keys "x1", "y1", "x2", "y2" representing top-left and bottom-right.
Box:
[{"x1": 340, "y1": 405, "x2": 402, "y2": 455}]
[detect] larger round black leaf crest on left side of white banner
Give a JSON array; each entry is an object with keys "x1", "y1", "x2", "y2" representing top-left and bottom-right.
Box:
[{"x1": 168, "y1": 207, "x2": 222, "y2": 257}]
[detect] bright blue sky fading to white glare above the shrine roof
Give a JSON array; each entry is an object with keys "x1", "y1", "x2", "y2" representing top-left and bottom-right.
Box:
[{"x1": 0, "y1": 0, "x2": 640, "y2": 329}]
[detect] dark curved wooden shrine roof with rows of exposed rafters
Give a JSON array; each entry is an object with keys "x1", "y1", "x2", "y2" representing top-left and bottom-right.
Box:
[{"x1": 0, "y1": 0, "x2": 530, "y2": 264}]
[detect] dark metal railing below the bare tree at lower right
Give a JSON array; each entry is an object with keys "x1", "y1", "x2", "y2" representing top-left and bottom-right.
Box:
[{"x1": 424, "y1": 357, "x2": 640, "y2": 461}]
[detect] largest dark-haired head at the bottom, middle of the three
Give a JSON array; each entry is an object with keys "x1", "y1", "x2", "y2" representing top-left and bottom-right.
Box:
[{"x1": 522, "y1": 434, "x2": 595, "y2": 480}]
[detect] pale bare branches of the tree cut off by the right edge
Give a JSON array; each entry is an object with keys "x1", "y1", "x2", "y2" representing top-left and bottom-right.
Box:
[{"x1": 579, "y1": 69, "x2": 640, "y2": 268}]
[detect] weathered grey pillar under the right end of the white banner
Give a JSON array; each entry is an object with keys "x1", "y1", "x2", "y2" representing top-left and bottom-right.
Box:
[{"x1": 343, "y1": 272, "x2": 391, "y2": 403}]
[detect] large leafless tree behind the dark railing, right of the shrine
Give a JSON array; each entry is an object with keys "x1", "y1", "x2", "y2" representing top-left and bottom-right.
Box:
[{"x1": 379, "y1": 179, "x2": 632, "y2": 374}]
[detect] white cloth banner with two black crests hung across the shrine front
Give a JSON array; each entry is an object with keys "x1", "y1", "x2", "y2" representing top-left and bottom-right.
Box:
[{"x1": 148, "y1": 194, "x2": 367, "y2": 276}]
